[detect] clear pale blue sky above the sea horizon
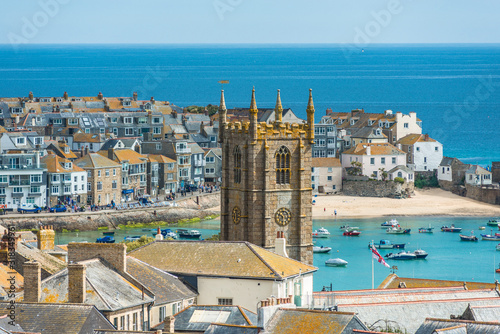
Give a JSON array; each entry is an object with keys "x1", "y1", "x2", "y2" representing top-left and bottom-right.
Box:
[{"x1": 0, "y1": 0, "x2": 500, "y2": 44}]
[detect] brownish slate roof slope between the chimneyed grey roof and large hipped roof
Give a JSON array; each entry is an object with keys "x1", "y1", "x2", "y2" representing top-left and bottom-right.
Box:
[{"x1": 127, "y1": 256, "x2": 198, "y2": 305}]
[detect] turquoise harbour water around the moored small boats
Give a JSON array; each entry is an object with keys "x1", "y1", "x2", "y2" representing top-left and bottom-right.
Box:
[{"x1": 56, "y1": 217, "x2": 500, "y2": 291}]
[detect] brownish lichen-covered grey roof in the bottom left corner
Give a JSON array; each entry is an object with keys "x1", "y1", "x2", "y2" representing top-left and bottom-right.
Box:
[{"x1": 0, "y1": 302, "x2": 114, "y2": 334}]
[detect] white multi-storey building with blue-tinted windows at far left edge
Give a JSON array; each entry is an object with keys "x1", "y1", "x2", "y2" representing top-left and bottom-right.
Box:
[{"x1": 0, "y1": 152, "x2": 47, "y2": 211}]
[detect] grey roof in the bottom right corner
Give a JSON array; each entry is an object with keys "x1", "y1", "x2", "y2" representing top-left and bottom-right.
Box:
[{"x1": 415, "y1": 318, "x2": 500, "y2": 334}]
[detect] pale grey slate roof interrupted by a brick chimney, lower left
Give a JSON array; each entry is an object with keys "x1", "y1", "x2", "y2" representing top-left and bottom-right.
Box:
[{"x1": 24, "y1": 259, "x2": 154, "y2": 311}]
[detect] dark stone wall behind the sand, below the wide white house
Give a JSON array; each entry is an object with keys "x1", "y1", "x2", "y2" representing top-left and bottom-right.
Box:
[{"x1": 342, "y1": 180, "x2": 413, "y2": 197}]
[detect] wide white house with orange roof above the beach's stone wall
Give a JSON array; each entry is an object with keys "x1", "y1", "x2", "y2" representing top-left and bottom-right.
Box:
[{"x1": 342, "y1": 143, "x2": 406, "y2": 180}]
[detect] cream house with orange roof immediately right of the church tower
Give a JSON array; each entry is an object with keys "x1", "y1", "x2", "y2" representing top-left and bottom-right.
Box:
[{"x1": 311, "y1": 158, "x2": 342, "y2": 194}]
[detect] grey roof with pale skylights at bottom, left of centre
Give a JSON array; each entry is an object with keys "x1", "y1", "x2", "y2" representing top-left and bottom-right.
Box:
[{"x1": 160, "y1": 305, "x2": 257, "y2": 332}]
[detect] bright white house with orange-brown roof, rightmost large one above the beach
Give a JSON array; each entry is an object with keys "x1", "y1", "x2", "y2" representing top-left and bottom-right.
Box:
[{"x1": 397, "y1": 133, "x2": 443, "y2": 172}]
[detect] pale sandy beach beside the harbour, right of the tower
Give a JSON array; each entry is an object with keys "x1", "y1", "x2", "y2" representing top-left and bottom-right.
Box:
[{"x1": 313, "y1": 189, "x2": 500, "y2": 219}]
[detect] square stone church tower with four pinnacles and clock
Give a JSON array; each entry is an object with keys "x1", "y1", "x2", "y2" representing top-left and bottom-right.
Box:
[{"x1": 219, "y1": 89, "x2": 314, "y2": 264}]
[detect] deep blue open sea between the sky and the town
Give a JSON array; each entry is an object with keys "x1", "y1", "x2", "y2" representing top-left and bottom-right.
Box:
[{"x1": 0, "y1": 45, "x2": 500, "y2": 165}]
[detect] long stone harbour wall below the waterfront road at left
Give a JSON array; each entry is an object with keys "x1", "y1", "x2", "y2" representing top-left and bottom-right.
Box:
[{"x1": 0, "y1": 193, "x2": 220, "y2": 231}]
